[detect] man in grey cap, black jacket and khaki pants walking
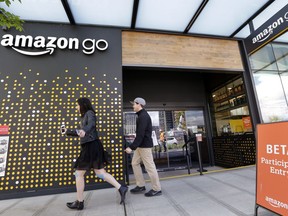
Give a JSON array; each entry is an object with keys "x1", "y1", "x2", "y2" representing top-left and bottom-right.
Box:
[{"x1": 125, "y1": 97, "x2": 162, "y2": 197}]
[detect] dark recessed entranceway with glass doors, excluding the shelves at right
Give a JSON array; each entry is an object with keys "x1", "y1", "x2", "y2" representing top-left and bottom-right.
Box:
[{"x1": 123, "y1": 67, "x2": 239, "y2": 176}]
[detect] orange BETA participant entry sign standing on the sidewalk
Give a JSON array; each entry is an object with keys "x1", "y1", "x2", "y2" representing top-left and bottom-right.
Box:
[{"x1": 255, "y1": 122, "x2": 288, "y2": 215}]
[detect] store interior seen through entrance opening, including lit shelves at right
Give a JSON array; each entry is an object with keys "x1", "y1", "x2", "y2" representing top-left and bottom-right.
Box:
[{"x1": 123, "y1": 68, "x2": 251, "y2": 176}]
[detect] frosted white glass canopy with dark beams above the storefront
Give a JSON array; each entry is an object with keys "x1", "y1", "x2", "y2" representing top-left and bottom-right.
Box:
[{"x1": 0, "y1": 0, "x2": 287, "y2": 41}]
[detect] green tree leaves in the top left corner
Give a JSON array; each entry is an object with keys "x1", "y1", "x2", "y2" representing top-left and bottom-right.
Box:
[{"x1": 0, "y1": 0, "x2": 24, "y2": 31}]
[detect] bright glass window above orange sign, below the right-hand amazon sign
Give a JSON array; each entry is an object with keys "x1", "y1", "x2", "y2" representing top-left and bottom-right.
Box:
[{"x1": 249, "y1": 33, "x2": 288, "y2": 123}]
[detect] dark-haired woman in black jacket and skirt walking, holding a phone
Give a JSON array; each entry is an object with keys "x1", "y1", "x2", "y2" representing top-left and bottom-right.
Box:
[{"x1": 61, "y1": 98, "x2": 128, "y2": 210}]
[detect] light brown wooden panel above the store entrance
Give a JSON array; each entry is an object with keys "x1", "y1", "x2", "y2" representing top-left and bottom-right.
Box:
[{"x1": 122, "y1": 31, "x2": 243, "y2": 71}]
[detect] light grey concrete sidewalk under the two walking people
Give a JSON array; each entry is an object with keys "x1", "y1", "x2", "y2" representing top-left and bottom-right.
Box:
[{"x1": 0, "y1": 166, "x2": 276, "y2": 216}]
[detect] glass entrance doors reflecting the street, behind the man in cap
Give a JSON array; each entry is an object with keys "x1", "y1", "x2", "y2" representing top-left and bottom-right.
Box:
[{"x1": 124, "y1": 108, "x2": 209, "y2": 173}]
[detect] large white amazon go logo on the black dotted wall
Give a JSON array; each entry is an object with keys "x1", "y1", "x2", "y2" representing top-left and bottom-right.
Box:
[{"x1": 1, "y1": 34, "x2": 108, "y2": 56}]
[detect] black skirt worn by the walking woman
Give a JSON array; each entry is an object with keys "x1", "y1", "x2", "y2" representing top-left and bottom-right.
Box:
[{"x1": 74, "y1": 139, "x2": 111, "y2": 170}]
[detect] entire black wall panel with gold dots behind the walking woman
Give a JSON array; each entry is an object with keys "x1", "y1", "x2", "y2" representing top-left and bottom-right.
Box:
[{"x1": 0, "y1": 23, "x2": 124, "y2": 198}]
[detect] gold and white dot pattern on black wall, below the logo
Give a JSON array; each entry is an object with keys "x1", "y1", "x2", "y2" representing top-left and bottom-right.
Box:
[{"x1": 0, "y1": 67, "x2": 124, "y2": 194}]
